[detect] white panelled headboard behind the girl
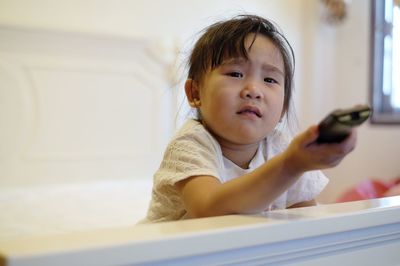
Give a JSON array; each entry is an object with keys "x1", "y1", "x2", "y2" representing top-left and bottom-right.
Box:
[{"x1": 0, "y1": 27, "x2": 177, "y2": 185}]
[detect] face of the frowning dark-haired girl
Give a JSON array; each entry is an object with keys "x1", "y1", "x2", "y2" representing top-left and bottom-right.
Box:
[{"x1": 193, "y1": 34, "x2": 285, "y2": 148}]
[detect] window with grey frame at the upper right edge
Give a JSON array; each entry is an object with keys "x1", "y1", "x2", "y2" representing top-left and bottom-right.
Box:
[{"x1": 371, "y1": 0, "x2": 400, "y2": 124}]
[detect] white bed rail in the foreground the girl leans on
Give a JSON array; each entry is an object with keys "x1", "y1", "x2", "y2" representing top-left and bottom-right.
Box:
[{"x1": 0, "y1": 196, "x2": 400, "y2": 266}]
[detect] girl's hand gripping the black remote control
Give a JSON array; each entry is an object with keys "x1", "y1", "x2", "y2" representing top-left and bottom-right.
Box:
[{"x1": 284, "y1": 125, "x2": 357, "y2": 172}]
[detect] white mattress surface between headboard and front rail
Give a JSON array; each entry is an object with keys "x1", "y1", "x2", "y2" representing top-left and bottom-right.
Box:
[{"x1": 0, "y1": 179, "x2": 151, "y2": 241}]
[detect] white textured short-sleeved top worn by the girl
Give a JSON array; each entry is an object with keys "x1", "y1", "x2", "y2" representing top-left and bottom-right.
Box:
[{"x1": 142, "y1": 120, "x2": 328, "y2": 222}]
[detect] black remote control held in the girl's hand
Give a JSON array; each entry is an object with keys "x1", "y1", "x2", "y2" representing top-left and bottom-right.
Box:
[{"x1": 317, "y1": 105, "x2": 372, "y2": 144}]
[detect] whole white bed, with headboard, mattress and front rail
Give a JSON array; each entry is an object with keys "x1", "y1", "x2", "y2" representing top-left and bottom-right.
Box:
[{"x1": 0, "y1": 26, "x2": 400, "y2": 266}]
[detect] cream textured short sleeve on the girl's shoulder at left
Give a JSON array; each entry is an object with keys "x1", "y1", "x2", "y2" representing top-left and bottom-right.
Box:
[{"x1": 154, "y1": 129, "x2": 219, "y2": 188}]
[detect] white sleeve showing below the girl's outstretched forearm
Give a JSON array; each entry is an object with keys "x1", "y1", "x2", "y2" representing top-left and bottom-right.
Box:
[{"x1": 286, "y1": 171, "x2": 329, "y2": 207}]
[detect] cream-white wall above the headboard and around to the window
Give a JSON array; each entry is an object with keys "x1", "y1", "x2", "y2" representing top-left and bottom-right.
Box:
[{"x1": 0, "y1": 0, "x2": 400, "y2": 201}]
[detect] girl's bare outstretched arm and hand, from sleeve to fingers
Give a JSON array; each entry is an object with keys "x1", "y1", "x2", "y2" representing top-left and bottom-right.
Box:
[{"x1": 176, "y1": 126, "x2": 356, "y2": 218}]
